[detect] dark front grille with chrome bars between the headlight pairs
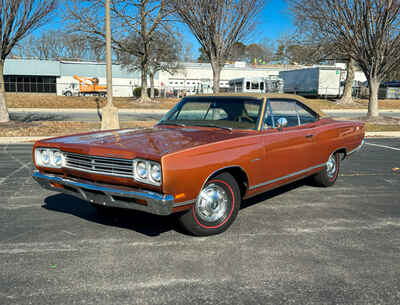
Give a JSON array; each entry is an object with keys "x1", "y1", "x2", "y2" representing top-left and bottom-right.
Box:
[{"x1": 64, "y1": 152, "x2": 133, "y2": 177}]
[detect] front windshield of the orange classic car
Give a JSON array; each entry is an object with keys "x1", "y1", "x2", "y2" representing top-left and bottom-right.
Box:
[{"x1": 159, "y1": 97, "x2": 262, "y2": 129}]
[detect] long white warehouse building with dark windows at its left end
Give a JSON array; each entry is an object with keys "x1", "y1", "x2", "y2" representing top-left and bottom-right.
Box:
[{"x1": 4, "y1": 59, "x2": 294, "y2": 97}]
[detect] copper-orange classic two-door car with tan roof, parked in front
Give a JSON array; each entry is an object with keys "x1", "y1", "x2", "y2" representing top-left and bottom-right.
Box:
[{"x1": 33, "y1": 95, "x2": 365, "y2": 235}]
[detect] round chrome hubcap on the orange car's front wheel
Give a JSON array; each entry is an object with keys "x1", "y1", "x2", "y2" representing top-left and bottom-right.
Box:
[{"x1": 196, "y1": 183, "x2": 228, "y2": 222}]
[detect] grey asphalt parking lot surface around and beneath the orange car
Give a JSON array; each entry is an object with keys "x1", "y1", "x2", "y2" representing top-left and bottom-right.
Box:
[{"x1": 0, "y1": 139, "x2": 400, "y2": 305}]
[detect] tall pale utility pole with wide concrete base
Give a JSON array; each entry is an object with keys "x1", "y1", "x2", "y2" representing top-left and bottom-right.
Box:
[{"x1": 101, "y1": 0, "x2": 119, "y2": 130}]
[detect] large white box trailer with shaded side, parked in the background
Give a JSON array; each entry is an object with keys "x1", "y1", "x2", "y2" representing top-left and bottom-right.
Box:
[{"x1": 279, "y1": 66, "x2": 345, "y2": 97}]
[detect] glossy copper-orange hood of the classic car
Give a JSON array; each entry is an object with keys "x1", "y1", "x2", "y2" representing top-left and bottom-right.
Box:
[{"x1": 41, "y1": 127, "x2": 251, "y2": 159}]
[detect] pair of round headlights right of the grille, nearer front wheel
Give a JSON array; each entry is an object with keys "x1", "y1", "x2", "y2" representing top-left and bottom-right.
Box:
[{"x1": 133, "y1": 159, "x2": 162, "y2": 186}]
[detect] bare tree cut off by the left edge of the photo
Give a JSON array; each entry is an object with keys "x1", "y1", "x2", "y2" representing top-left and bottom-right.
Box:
[{"x1": 0, "y1": 0, "x2": 57, "y2": 122}]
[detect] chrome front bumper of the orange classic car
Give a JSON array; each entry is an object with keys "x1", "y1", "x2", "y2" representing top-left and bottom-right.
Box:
[{"x1": 33, "y1": 171, "x2": 174, "y2": 215}]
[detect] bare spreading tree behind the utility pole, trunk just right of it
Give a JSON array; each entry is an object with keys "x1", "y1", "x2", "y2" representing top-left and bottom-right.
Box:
[{"x1": 69, "y1": 0, "x2": 171, "y2": 102}]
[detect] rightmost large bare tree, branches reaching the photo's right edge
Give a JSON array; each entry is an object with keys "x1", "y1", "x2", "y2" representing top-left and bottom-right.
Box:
[{"x1": 288, "y1": 0, "x2": 400, "y2": 118}]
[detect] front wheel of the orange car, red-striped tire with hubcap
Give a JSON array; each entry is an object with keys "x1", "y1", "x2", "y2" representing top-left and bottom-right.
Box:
[{"x1": 179, "y1": 173, "x2": 241, "y2": 236}]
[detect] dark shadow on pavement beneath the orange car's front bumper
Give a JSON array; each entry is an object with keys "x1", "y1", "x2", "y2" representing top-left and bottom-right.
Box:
[{"x1": 43, "y1": 194, "x2": 186, "y2": 237}]
